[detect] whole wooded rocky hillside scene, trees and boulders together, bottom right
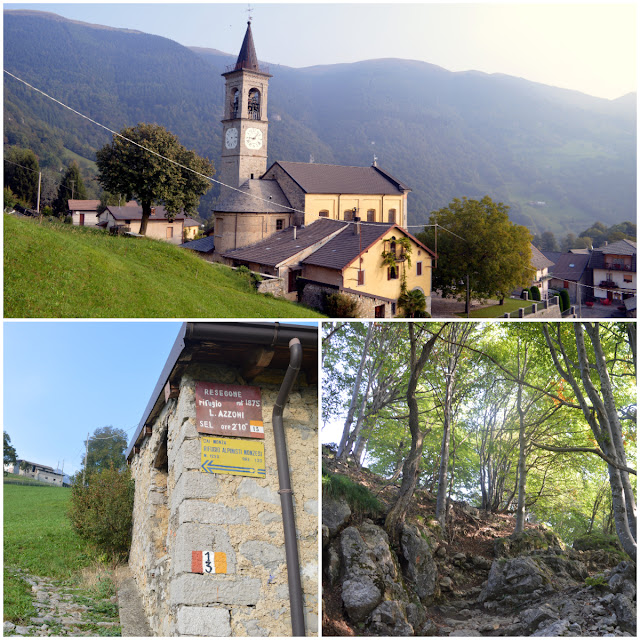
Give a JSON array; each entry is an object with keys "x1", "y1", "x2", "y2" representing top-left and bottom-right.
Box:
[{"x1": 322, "y1": 322, "x2": 637, "y2": 636}]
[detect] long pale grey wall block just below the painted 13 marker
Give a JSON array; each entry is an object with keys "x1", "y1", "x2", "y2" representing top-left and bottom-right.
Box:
[{"x1": 169, "y1": 573, "x2": 261, "y2": 604}]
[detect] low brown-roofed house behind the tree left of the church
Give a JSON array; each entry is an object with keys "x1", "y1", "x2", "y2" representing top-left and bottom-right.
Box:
[{"x1": 97, "y1": 202, "x2": 186, "y2": 244}]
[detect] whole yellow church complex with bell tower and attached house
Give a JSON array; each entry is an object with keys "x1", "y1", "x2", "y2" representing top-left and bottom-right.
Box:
[{"x1": 204, "y1": 22, "x2": 435, "y2": 318}]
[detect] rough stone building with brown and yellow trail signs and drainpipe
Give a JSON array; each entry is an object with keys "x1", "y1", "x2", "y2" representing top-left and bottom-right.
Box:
[{"x1": 127, "y1": 322, "x2": 318, "y2": 636}]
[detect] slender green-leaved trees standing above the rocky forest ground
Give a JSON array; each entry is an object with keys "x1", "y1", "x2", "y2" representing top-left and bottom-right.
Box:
[{"x1": 323, "y1": 323, "x2": 637, "y2": 559}]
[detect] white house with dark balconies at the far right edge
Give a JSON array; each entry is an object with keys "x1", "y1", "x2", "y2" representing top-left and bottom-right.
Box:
[{"x1": 589, "y1": 239, "x2": 638, "y2": 303}]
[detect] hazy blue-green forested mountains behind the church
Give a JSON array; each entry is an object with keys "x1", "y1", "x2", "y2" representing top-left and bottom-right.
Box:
[{"x1": 4, "y1": 11, "x2": 636, "y2": 233}]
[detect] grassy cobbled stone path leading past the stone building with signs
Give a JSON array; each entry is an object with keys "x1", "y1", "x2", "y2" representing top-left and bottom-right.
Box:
[{"x1": 2, "y1": 569, "x2": 120, "y2": 637}]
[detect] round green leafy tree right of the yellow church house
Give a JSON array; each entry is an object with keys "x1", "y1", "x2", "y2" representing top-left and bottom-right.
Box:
[{"x1": 418, "y1": 196, "x2": 532, "y2": 312}]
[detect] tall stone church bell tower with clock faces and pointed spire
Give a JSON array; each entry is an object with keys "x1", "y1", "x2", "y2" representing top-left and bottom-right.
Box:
[{"x1": 218, "y1": 20, "x2": 271, "y2": 189}]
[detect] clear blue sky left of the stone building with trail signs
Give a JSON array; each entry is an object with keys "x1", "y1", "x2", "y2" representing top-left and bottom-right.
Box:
[{"x1": 3, "y1": 320, "x2": 181, "y2": 475}]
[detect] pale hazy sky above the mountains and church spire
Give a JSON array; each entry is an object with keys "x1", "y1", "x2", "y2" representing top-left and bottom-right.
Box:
[{"x1": 4, "y1": 2, "x2": 637, "y2": 98}]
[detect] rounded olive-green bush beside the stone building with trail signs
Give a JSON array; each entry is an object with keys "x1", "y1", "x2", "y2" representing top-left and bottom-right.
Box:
[{"x1": 68, "y1": 468, "x2": 134, "y2": 557}]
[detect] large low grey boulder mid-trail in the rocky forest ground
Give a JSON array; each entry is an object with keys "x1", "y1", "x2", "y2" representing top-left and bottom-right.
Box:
[{"x1": 478, "y1": 556, "x2": 550, "y2": 602}]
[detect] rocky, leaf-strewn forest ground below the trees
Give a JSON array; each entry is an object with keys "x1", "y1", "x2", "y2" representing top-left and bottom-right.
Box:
[{"x1": 323, "y1": 458, "x2": 636, "y2": 637}]
